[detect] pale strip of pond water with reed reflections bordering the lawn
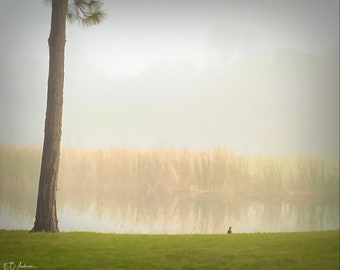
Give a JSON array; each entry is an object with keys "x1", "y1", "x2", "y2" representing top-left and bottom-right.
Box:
[{"x1": 0, "y1": 203, "x2": 339, "y2": 234}]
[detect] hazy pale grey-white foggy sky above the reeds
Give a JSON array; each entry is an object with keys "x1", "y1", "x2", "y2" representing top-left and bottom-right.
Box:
[{"x1": 0, "y1": 0, "x2": 339, "y2": 155}]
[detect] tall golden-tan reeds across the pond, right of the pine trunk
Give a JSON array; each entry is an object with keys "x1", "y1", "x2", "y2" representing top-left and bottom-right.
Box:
[{"x1": 55, "y1": 149, "x2": 339, "y2": 200}]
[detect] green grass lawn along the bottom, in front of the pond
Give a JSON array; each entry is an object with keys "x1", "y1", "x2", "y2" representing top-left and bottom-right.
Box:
[{"x1": 0, "y1": 230, "x2": 339, "y2": 270}]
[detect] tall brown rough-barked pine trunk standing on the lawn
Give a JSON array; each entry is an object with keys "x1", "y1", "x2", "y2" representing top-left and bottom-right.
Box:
[{"x1": 31, "y1": 0, "x2": 67, "y2": 232}]
